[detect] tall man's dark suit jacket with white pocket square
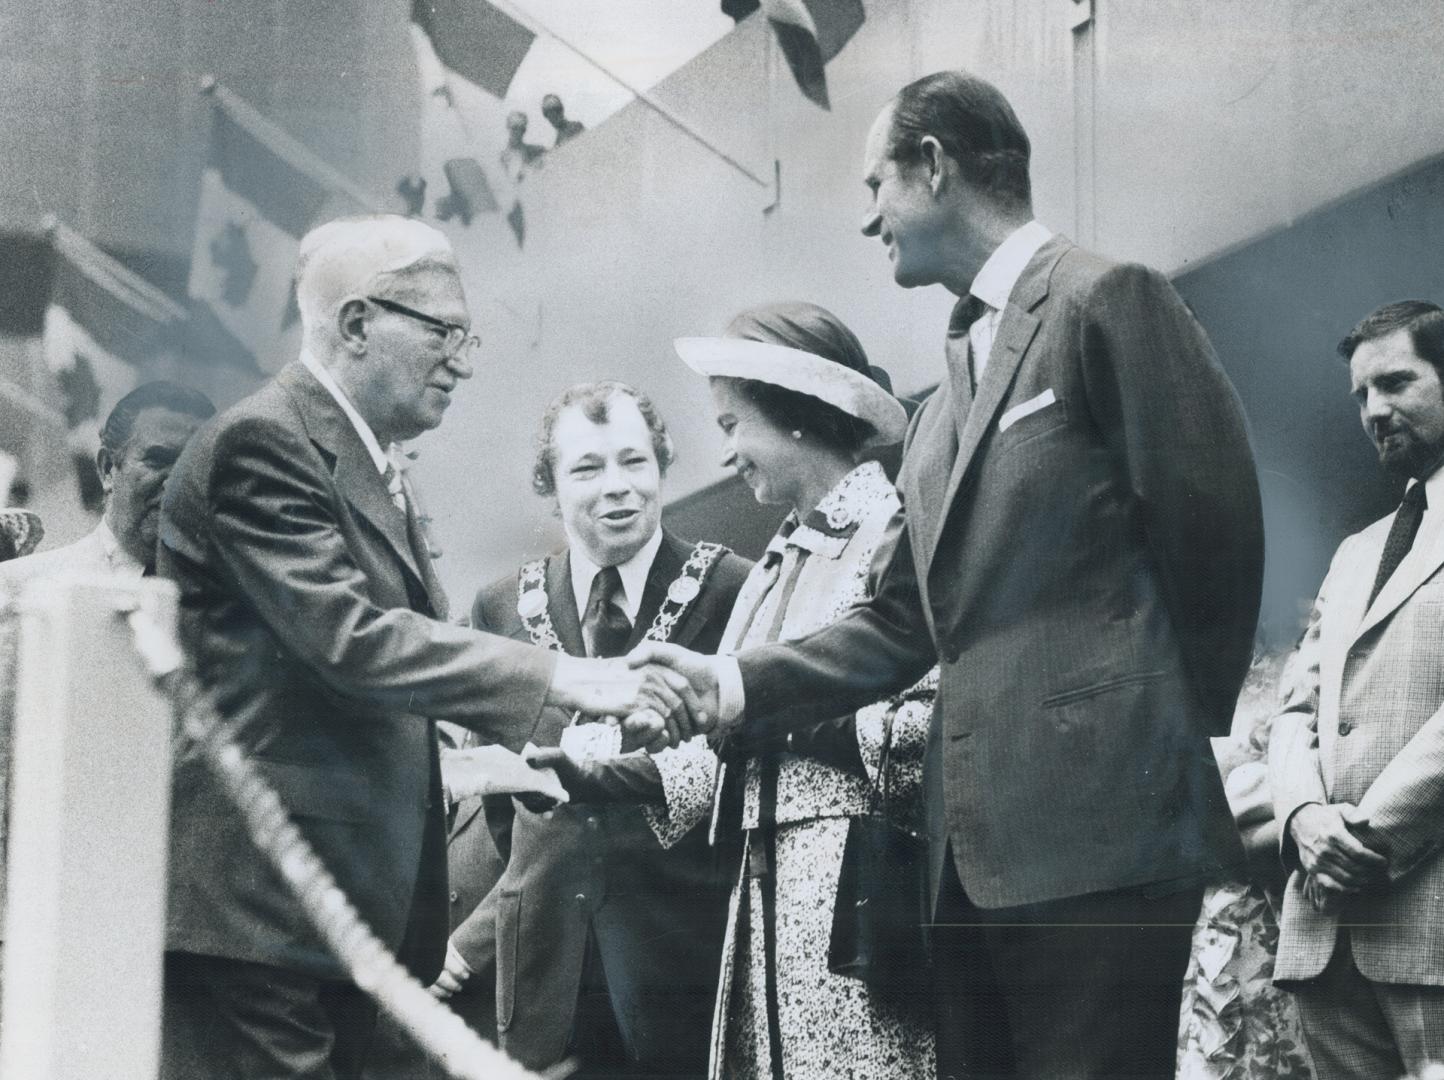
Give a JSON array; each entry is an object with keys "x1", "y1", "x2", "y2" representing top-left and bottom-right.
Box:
[{"x1": 741, "y1": 237, "x2": 1264, "y2": 908}]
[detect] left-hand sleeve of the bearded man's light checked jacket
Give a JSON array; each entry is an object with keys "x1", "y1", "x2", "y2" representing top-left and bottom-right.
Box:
[{"x1": 1268, "y1": 540, "x2": 1349, "y2": 869}]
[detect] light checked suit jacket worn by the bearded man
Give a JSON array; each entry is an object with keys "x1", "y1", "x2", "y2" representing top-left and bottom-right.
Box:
[{"x1": 1269, "y1": 502, "x2": 1444, "y2": 986}]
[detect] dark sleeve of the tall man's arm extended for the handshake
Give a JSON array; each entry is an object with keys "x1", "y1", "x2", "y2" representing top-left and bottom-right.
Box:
[{"x1": 738, "y1": 510, "x2": 937, "y2": 741}]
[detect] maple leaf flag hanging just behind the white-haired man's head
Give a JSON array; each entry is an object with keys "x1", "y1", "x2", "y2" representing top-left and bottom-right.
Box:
[{"x1": 189, "y1": 79, "x2": 375, "y2": 371}]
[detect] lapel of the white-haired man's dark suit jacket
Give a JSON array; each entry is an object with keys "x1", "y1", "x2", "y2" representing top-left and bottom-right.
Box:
[{"x1": 277, "y1": 362, "x2": 426, "y2": 589}]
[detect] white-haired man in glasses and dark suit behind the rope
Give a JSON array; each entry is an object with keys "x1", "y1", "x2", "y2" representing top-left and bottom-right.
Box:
[{"x1": 159, "y1": 217, "x2": 680, "y2": 1080}]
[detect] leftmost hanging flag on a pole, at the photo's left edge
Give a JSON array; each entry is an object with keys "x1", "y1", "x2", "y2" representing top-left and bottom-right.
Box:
[{"x1": 42, "y1": 218, "x2": 186, "y2": 459}]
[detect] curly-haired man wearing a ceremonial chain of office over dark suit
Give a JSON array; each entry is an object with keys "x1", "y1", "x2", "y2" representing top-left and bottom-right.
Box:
[{"x1": 442, "y1": 381, "x2": 748, "y2": 1077}]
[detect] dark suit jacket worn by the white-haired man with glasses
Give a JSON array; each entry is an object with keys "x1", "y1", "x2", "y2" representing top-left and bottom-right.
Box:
[{"x1": 159, "y1": 364, "x2": 554, "y2": 982}]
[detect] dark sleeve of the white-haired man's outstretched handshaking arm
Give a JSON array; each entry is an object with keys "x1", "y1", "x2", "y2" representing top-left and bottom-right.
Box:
[{"x1": 206, "y1": 420, "x2": 556, "y2": 746}]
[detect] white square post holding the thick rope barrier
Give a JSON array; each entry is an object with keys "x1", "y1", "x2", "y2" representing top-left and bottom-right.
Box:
[{"x1": 0, "y1": 579, "x2": 176, "y2": 1080}]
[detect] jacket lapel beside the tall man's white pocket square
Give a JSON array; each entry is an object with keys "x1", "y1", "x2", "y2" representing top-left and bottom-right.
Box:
[{"x1": 918, "y1": 237, "x2": 1071, "y2": 576}]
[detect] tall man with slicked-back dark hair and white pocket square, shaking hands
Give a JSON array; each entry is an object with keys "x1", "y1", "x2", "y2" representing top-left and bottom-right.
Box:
[{"x1": 637, "y1": 72, "x2": 1264, "y2": 1080}]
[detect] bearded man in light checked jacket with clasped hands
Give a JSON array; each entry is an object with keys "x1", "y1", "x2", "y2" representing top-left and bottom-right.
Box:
[{"x1": 1269, "y1": 300, "x2": 1444, "y2": 1080}]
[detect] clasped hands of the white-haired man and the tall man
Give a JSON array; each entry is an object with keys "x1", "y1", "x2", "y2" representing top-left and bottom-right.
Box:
[{"x1": 546, "y1": 641, "x2": 735, "y2": 752}]
